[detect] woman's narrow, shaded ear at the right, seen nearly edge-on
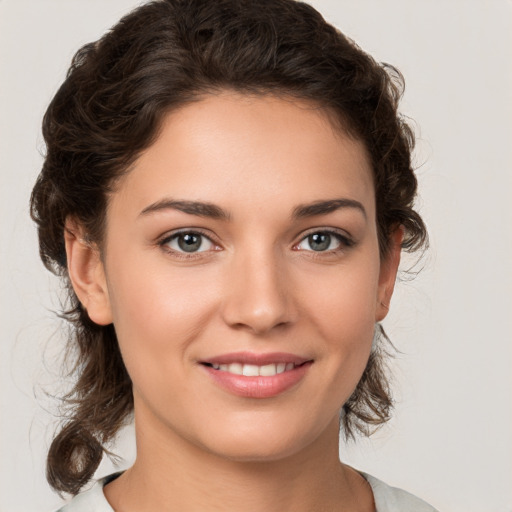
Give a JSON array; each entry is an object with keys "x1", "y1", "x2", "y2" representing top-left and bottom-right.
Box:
[{"x1": 375, "y1": 226, "x2": 404, "y2": 322}]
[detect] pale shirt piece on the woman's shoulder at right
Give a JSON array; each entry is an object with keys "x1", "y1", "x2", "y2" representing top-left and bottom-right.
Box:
[{"x1": 361, "y1": 473, "x2": 437, "y2": 512}]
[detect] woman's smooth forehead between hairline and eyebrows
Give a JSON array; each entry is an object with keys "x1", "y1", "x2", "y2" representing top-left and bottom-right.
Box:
[{"x1": 112, "y1": 92, "x2": 374, "y2": 218}]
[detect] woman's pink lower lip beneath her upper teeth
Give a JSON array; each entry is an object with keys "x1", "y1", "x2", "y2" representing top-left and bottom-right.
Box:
[{"x1": 202, "y1": 362, "x2": 312, "y2": 398}]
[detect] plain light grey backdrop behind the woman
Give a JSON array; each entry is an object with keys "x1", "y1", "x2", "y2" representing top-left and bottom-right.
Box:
[{"x1": 0, "y1": 0, "x2": 512, "y2": 512}]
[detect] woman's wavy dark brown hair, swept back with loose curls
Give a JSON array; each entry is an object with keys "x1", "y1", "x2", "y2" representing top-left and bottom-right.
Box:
[{"x1": 31, "y1": 0, "x2": 426, "y2": 494}]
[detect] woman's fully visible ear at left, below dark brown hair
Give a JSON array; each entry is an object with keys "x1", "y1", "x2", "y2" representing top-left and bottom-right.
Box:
[{"x1": 64, "y1": 218, "x2": 112, "y2": 325}]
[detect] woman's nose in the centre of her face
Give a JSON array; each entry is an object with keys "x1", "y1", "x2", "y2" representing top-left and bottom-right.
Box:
[{"x1": 222, "y1": 249, "x2": 296, "y2": 335}]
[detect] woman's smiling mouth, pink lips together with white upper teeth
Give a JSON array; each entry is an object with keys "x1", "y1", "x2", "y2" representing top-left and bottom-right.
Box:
[{"x1": 200, "y1": 353, "x2": 314, "y2": 398}]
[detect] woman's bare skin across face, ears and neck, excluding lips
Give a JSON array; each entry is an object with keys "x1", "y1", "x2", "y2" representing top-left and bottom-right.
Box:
[{"x1": 66, "y1": 92, "x2": 401, "y2": 512}]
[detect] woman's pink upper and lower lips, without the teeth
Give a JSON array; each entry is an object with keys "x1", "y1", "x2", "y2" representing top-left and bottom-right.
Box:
[{"x1": 201, "y1": 352, "x2": 313, "y2": 398}]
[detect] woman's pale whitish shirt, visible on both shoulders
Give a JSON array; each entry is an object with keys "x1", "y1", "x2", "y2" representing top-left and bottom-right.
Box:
[{"x1": 57, "y1": 473, "x2": 437, "y2": 512}]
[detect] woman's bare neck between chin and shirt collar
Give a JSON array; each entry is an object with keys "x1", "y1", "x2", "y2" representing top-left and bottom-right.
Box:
[{"x1": 105, "y1": 412, "x2": 373, "y2": 512}]
